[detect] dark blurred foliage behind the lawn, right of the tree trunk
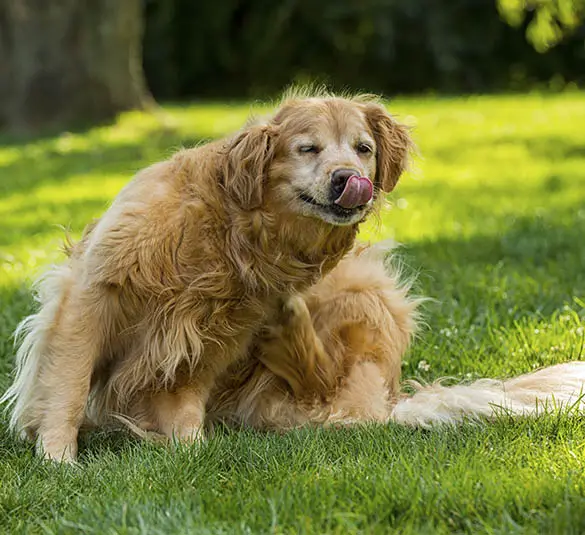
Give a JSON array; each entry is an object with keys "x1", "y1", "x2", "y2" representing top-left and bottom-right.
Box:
[{"x1": 143, "y1": 0, "x2": 585, "y2": 100}]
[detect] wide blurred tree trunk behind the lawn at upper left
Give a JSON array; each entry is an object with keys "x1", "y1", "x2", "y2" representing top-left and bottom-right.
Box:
[{"x1": 0, "y1": 0, "x2": 151, "y2": 133}]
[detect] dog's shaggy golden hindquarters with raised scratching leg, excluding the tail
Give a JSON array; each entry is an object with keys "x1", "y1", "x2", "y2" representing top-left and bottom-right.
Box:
[{"x1": 208, "y1": 245, "x2": 419, "y2": 430}]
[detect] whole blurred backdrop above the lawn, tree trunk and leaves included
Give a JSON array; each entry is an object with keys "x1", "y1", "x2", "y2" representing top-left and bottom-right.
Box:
[{"x1": 0, "y1": 0, "x2": 585, "y2": 136}]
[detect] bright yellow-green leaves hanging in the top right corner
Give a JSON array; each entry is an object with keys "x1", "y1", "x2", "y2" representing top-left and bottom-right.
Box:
[{"x1": 498, "y1": 0, "x2": 585, "y2": 52}]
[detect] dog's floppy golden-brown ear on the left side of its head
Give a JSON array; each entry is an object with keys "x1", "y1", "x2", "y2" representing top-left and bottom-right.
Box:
[{"x1": 223, "y1": 125, "x2": 274, "y2": 210}]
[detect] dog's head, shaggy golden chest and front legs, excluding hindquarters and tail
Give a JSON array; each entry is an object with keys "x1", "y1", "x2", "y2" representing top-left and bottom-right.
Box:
[{"x1": 3, "y1": 90, "x2": 411, "y2": 461}]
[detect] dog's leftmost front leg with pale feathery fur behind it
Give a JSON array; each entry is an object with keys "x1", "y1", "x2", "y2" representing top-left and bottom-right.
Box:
[{"x1": 3, "y1": 266, "x2": 109, "y2": 461}]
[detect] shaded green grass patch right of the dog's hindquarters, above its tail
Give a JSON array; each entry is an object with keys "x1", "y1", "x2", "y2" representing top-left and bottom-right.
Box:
[{"x1": 405, "y1": 210, "x2": 585, "y2": 329}]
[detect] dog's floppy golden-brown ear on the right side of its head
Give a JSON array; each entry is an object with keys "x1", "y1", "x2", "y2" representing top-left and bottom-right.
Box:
[{"x1": 365, "y1": 103, "x2": 414, "y2": 192}]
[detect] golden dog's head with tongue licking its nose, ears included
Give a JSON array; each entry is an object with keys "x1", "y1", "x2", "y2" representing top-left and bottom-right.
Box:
[{"x1": 224, "y1": 93, "x2": 412, "y2": 226}]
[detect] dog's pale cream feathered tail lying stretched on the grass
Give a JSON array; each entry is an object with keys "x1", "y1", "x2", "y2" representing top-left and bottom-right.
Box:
[{"x1": 390, "y1": 362, "x2": 585, "y2": 427}]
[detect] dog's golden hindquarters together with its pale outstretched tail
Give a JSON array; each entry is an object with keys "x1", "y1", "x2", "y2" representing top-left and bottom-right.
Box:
[{"x1": 208, "y1": 245, "x2": 585, "y2": 430}]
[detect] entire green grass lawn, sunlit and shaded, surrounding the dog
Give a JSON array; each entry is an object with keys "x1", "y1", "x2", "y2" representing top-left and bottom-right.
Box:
[{"x1": 0, "y1": 93, "x2": 585, "y2": 534}]
